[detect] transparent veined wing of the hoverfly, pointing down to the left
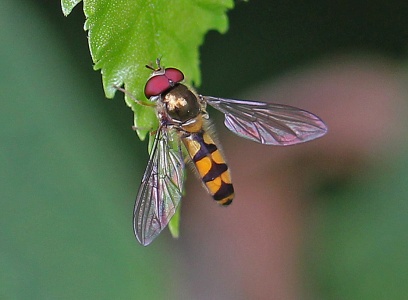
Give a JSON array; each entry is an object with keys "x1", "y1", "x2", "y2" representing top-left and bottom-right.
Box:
[{"x1": 133, "y1": 126, "x2": 184, "y2": 246}]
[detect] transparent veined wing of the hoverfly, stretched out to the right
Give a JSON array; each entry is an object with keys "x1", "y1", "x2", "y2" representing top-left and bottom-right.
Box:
[{"x1": 201, "y1": 96, "x2": 327, "y2": 146}]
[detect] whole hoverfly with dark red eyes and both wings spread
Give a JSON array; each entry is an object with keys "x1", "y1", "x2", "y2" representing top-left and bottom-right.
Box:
[{"x1": 126, "y1": 59, "x2": 327, "y2": 246}]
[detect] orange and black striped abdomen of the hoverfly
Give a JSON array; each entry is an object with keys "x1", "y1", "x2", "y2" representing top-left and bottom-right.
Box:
[{"x1": 182, "y1": 130, "x2": 234, "y2": 205}]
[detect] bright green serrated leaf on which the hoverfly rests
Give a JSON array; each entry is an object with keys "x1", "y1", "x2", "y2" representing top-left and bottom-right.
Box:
[{"x1": 62, "y1": 0, "x2": 233, "y2": 139}]
